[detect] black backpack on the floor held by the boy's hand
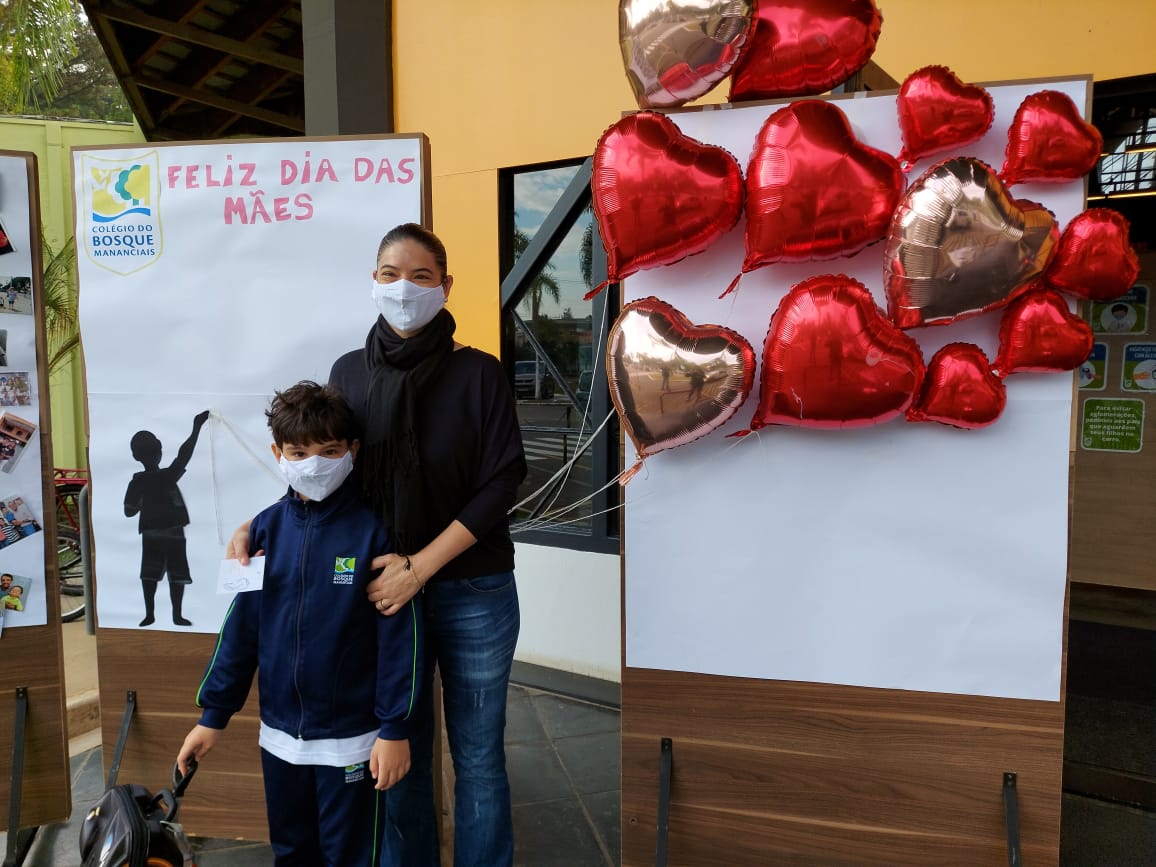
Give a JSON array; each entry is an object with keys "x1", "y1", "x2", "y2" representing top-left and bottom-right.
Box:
[{"x1": 80, "y1": 762, "x2": 197, "y2": 867}]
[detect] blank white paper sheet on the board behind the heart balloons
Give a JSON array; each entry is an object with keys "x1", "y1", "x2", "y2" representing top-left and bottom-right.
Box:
[{"x1": 623, "y1": 80, "x2": 1090, "y2": 702}]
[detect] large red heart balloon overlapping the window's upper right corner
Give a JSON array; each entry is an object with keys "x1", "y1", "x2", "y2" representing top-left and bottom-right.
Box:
[{"x1": 586, "y1": 111, "x2": 743, "y2": 298}]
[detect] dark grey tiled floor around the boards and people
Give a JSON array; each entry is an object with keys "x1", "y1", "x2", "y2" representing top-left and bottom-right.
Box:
[{"x1": 11, "y1": 687, "x2": 620, "y2": 867}]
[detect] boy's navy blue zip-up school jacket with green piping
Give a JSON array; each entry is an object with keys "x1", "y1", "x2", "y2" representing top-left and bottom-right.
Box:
[{"x1": 197, "y1": 477, "x2": 423, "y2": 740}]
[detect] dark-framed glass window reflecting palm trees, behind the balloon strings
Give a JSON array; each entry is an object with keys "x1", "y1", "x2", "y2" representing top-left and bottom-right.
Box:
[{"x1": 501, "y1": 163, "x2": 618, "y2": 551}]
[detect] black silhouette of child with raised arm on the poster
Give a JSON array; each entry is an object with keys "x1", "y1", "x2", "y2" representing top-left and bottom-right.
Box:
[{"x1": 125, "y1": 409, "x2": 209, "y2": 627}]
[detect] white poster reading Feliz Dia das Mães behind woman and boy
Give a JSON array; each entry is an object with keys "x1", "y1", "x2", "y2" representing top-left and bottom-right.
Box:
[{"x1": 73, "y1": 135, "x2": 429, "y2": 632}]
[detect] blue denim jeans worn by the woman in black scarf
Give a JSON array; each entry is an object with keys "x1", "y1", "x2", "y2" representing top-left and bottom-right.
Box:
[{"x1": 387, "y1": 572, "x2": 520, "y2": 867}]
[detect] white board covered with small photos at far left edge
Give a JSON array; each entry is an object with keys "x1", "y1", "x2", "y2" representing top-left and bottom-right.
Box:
[{"x1": 0, "y1": 154, "x2": 49, "y2": 630}]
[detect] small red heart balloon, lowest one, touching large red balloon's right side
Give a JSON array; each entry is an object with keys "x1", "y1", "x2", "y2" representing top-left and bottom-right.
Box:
[{"x1": 907, "y1": 343, "x2": 1008, "y2": 430}]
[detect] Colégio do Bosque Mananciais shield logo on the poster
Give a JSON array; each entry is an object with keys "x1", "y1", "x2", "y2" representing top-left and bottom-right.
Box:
[{"x1": 80, "y1": 150, "x2": 163, "y2": 274}]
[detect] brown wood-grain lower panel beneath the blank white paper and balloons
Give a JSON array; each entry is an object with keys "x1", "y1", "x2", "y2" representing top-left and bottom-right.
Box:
[{"x1": 622, "y1": 668, "x2": 1064, "y2": 866}]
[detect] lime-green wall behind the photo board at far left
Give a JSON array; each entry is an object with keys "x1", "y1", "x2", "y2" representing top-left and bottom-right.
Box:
[{"x1": 0, "y1": 117, "x2": 145, "y2": 467}]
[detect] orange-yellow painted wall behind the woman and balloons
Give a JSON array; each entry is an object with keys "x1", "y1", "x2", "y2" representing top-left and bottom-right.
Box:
[{"x1": 393, "y1": 0, "x2": 1156, "y2": 351}]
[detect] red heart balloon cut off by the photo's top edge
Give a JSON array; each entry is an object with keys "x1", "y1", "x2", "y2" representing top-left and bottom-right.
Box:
[{"x1": 731, "y1": 0, "x2": 883, "y2": 102}]
